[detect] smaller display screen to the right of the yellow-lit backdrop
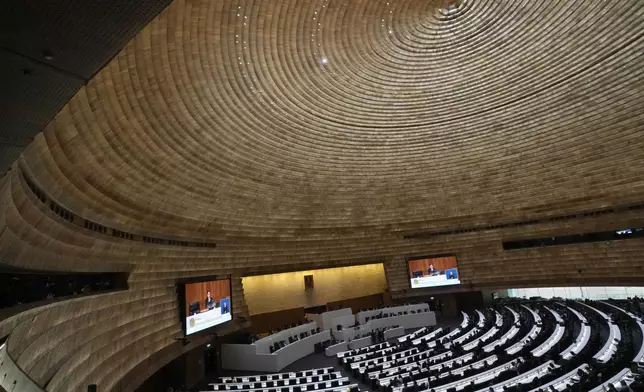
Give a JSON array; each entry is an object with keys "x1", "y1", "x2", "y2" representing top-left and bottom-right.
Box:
[{"x1": 407, "y1": 256, "x2": 461, "y2": 289}]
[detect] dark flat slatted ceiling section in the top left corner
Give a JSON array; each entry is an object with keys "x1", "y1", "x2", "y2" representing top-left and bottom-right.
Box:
[{"x1": 0, "y1": 0, "x2": 170, "y2": 176}]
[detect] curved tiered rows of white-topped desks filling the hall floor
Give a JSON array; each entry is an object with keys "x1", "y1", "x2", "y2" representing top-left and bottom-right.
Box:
[{"x1": 213, "y1": 303, "x2": 644, "y2": 392}]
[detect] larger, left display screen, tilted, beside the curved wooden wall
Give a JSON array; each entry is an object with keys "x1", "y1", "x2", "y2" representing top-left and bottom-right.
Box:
[{"x1": 182, "y1": 279, "x2": 233, "y2": 336}]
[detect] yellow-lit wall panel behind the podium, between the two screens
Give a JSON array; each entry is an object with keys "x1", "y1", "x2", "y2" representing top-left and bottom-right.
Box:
[{"x1": 242, "y1": 263, "x2": 387, "y2": 315}]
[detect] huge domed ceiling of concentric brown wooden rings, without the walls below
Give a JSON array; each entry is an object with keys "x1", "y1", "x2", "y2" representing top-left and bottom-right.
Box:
[{"x1": 11, "y1": 0, "x2": 644, "y2": 243}]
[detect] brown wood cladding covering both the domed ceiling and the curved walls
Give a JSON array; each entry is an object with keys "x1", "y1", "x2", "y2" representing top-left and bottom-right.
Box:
[{"x1": 0, "y1": 0, "x2": 644, "y2": 392}]
